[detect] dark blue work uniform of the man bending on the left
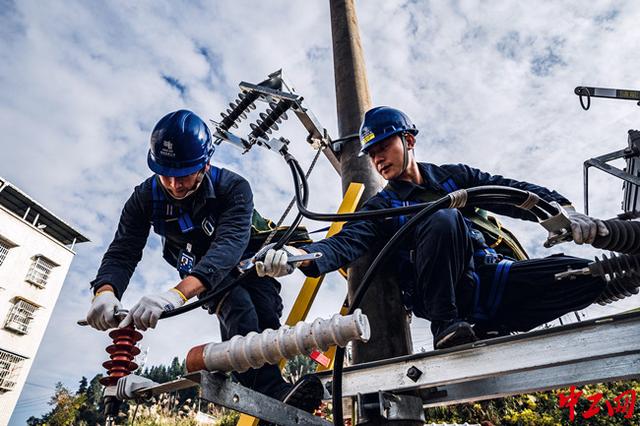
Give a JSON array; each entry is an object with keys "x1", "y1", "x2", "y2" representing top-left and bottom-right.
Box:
[{"x1": 91, "y1": 167, "x2": 289, "y2": 397}]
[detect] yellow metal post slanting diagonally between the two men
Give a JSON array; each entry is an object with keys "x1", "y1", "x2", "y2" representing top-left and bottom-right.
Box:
[{"x1": 236, "y1": 182, "x2": 364, "y2": 426}]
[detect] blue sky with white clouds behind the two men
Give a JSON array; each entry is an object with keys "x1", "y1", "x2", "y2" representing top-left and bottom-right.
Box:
[{"x1": 0, "y1": 0, "x2": 640, "y2": 425}]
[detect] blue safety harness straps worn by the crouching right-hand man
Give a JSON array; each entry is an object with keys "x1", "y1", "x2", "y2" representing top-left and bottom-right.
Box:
[{"x1": 378, "y1": 177, "x2": 528, "y2": 320}]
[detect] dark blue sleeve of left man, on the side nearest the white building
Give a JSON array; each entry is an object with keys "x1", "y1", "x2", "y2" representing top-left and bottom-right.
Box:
[{"x1": 91, "y1": 186, "x2": 151, "y2": 299}]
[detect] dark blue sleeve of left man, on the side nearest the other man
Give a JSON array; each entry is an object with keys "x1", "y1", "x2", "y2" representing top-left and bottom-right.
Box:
[{"x1": 191, "y1": 178, "x2": 253, "y2": 289}]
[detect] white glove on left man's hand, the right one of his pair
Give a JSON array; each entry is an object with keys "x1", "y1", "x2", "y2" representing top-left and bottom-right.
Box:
[{"x1": 118, "y1": 288, "x2": 186, "y2": 331}]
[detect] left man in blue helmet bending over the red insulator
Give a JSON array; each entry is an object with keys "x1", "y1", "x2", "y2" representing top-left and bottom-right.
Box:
[{"x1": 87, "y1": 110, "x2": 322, "y2": 411}]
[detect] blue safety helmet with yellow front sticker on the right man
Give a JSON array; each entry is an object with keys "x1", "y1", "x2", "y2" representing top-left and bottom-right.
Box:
[{"x1": 359, "y1": 106, "x2": 418, "y2": 157}]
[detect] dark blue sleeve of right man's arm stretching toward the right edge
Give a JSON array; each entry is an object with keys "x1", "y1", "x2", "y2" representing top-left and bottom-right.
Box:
[{"x1": 444, "y1": 164, "x2": 571, "y2": 221}]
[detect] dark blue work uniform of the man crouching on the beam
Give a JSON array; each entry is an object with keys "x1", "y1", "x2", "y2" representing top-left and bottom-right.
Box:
[{"x1": 302, "y1": 163, "x2": 605, "y2": 340}]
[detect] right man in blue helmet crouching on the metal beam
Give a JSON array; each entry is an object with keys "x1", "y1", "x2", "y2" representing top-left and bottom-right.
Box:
[{"x1": 257, "y1": 106, "x2": 608, "y2": 349}]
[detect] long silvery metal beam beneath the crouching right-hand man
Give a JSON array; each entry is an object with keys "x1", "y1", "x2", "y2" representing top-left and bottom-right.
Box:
[{"x1": 318, "y1": 312, "x2": 640, "y2": 407}]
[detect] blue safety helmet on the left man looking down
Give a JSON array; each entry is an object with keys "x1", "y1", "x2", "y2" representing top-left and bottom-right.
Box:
[{"x1": 147, "y1": 109, "x2": 215, "y2": 177}]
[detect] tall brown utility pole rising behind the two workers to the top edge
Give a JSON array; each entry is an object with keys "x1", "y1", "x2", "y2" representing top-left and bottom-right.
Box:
[{"x1": 329, "y1": 0, "x2": 411, "y2": 382}]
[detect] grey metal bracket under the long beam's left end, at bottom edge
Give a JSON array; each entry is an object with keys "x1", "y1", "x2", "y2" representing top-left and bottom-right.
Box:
[{"x1": 356, "y1": 391, "x2": 425, "y2": 424}]
